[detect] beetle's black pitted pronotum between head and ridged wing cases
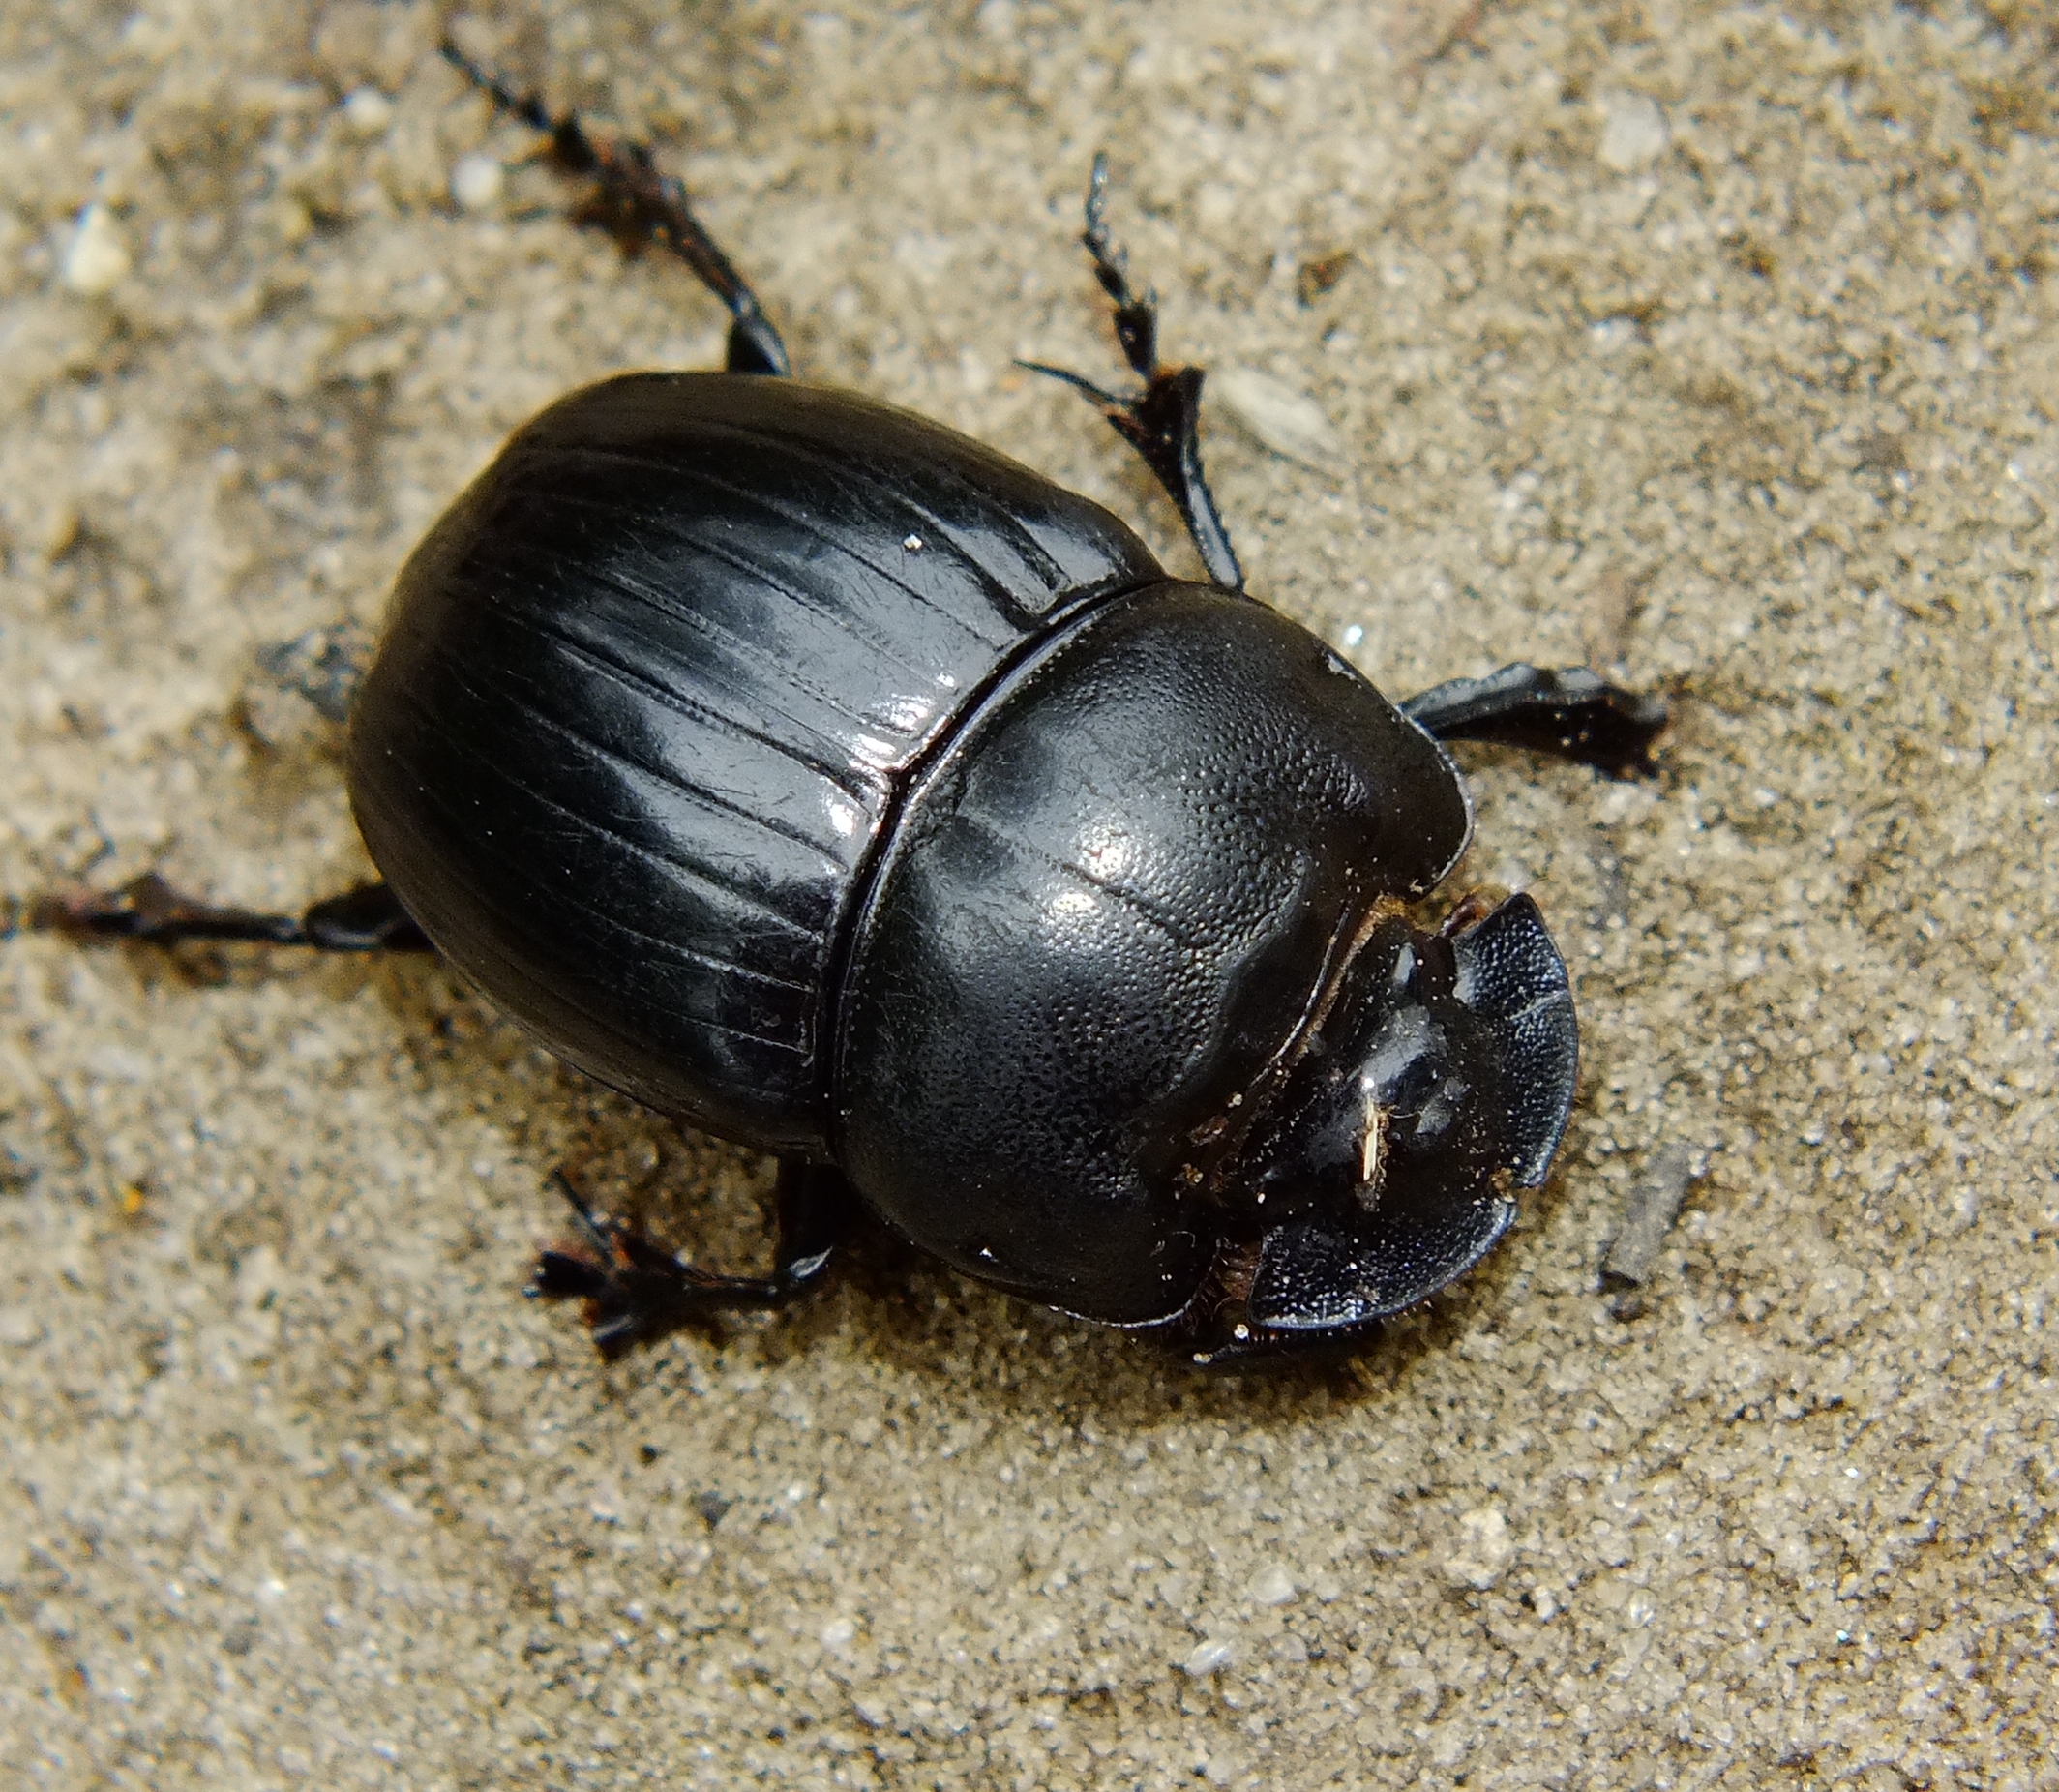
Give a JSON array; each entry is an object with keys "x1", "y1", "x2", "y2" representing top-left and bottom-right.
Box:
[{"x1": 838, "y1": 582, "x2": 1470, "y2": 1325}]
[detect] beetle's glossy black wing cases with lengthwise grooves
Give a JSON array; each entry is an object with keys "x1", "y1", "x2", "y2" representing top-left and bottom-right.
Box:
[{"x1": 348, "y1": 373, "x2": 1163, "y2": 1157}]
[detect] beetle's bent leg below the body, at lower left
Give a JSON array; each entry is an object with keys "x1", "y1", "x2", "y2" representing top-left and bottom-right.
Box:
[{"x1": 525, "y1": 1162, "x2": 856, "y2": 1361}]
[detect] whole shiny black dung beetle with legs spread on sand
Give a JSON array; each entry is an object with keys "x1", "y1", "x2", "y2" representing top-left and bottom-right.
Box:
[{"x1": 45, "y1": 44, "x2": 1666, "y2": 1361}]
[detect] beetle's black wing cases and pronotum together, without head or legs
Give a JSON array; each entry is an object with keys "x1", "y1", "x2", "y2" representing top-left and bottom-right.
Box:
[{"x1": 350, "y1": 373, "x2": 1482, "y2": 1325}]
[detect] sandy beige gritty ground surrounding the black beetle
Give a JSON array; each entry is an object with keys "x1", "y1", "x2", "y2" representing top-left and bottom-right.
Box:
[{"x1": 0, "y1": 0, "x2": 2059, "y2": 1792}]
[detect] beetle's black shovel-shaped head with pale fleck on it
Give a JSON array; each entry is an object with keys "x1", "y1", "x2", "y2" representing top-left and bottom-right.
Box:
[{"x1": 1223, "y1": 896, "x2": 1579, "y2": 1354}]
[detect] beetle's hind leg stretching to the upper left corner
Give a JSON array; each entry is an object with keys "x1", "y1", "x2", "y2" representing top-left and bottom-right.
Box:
[{"x1": 440, "y1": 37, "x2": 792, "y2": 374}]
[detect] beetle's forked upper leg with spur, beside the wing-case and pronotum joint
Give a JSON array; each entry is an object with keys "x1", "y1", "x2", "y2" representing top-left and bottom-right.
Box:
[{"x1": 1021, "y1": 155, "x2": 1243, "y2": 591}]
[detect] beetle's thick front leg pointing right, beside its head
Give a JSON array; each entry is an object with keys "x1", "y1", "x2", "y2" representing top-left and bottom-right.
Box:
[{"x1": 1402, "y1": 666, "x2": 1668, "y2": 779}]
